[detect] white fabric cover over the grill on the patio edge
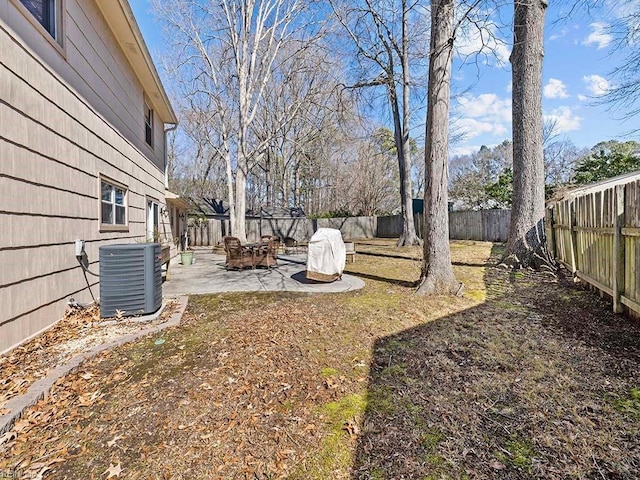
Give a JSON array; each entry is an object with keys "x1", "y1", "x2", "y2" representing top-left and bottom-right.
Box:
[{"x1": 307, "y1": 228, "x2": 347, "y2": 282}]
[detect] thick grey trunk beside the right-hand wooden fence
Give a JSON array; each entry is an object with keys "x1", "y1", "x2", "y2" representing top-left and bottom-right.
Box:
[{"x1": 504, "y1": 0, "x2": 552, "y2": 268}]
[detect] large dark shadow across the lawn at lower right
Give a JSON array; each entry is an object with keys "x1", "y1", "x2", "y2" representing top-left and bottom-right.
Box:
[{"x1": 351, "y1": 246, "x2": 640, "y2": 480}]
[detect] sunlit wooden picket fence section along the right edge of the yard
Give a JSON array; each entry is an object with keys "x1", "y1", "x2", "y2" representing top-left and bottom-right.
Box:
[{"x1": 545, "y1": 175, "x2": 640, "y2": 313}]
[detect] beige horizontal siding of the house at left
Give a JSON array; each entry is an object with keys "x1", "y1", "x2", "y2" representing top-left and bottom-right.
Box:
[{"x1": 0, "y1": 0, "x2": 172, "y2": 352}]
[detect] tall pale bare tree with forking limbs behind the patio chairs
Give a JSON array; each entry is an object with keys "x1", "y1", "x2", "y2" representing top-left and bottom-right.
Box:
[{"x1": 155, "y1": 0, "x2": 305, "y2": 241}]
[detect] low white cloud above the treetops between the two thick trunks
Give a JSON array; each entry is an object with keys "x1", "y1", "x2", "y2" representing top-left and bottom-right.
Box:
[{"x1": 456, "y1": 93, "x2": 511, "y2": 139}]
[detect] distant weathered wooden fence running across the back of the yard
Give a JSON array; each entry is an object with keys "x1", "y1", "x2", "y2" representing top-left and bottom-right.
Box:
[{"x1": 188, "y1": 210, "x2": 510, "y2": 246}]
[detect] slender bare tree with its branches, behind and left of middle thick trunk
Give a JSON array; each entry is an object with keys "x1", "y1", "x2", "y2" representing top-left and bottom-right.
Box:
[{"x1": 330, "y1": 0, "x2": 420, "y2": 246}]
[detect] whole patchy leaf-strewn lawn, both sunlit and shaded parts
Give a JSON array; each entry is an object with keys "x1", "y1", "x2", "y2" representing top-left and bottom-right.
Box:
[{"x1": 0, "y1": 240, "x2": 640, "y2": 480}]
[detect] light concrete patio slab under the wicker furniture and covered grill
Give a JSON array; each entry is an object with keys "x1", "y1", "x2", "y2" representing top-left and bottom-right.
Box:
[{"x1": 162, "y1": 249, "x2": 364, "y2": 295}]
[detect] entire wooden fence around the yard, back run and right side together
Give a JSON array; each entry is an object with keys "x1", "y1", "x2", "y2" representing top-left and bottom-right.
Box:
[{"x1": 182, "y1": 193, "x2": 640, "y2": 313}]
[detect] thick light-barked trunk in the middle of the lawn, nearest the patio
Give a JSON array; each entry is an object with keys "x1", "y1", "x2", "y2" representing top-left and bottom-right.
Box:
[{"x1": 418, "y1": 0, "x2": 462, "y2": 295}]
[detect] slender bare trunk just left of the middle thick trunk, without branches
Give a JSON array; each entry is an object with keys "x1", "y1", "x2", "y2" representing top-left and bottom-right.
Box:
[{"x1": 396, "y1": 0, "x2": 420, "y2": 247}]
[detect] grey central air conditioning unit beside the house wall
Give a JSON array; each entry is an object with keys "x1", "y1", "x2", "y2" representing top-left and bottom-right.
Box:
[{"x1": 100, "y1": 243, "x2": 162, "y2": 317}]
